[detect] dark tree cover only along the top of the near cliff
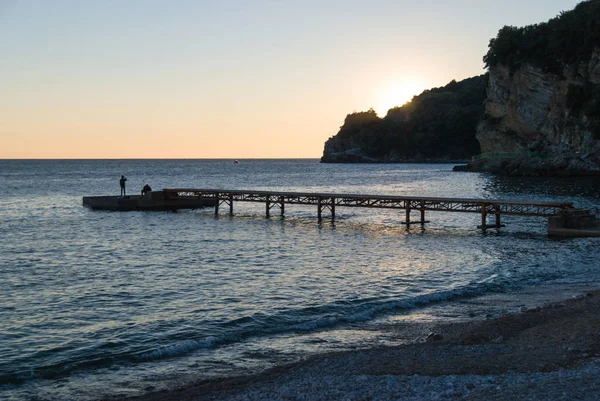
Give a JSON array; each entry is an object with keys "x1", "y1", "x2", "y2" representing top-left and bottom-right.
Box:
[{"x1": 483, "y1": 0, "x2": 600, "y2": 75}]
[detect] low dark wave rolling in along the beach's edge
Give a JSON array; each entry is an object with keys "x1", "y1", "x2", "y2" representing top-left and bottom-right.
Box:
[{"x1": 0, "y1": 282, "x2": 528, "y2": 384}]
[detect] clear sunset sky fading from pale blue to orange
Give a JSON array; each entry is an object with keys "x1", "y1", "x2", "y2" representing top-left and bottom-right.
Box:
[{"x1": 0, "y1": 0, "x2": 579, "y2": 159}]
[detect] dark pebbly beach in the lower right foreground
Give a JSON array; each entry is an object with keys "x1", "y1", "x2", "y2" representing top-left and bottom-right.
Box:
[{"x1": 117, "y1": 290, "x2": 600, "y2": 401}]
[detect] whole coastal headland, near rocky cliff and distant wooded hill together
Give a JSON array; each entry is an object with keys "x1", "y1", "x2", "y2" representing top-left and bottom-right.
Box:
[{"x1": 321, "y1": 0, "x2": 600, "y2": 175}]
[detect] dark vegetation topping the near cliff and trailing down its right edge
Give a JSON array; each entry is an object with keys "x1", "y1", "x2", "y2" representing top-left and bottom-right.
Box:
[{"x1": 483, "y1": 0, "x2": 600, "y2": 140}]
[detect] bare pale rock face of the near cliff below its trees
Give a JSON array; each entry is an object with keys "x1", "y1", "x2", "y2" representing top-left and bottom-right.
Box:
[{"x1": 476, "y1": 49, "x2": 600, "y2": 172}]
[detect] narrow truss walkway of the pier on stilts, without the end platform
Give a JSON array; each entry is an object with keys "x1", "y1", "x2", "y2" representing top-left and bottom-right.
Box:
[{"x1": 163, "y1": 188, "x2": 574, "y2": 230}]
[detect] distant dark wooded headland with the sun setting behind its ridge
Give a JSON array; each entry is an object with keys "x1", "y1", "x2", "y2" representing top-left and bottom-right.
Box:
[{"x1": 321, "y1": 75, "x2": 487, "y2": 163}]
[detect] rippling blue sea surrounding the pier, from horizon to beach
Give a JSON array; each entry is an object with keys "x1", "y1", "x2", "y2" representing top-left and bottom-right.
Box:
[{"x1": 0, "y1": 159, "x2": 600, "y2": 401}]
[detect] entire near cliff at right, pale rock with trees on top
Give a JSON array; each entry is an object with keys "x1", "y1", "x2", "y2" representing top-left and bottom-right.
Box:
[{"x1": 462, "y1": 0, "x2": 600, "y2": 175}]
